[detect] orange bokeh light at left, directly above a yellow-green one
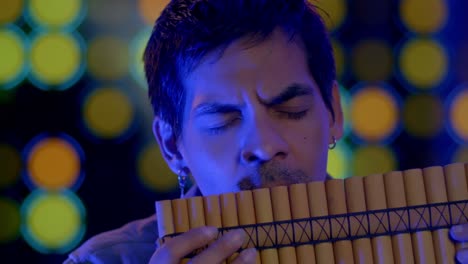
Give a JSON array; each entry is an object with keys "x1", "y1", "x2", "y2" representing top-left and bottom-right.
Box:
[{"x1": 24, "y1": 135, "x2": 84, "y2": 190}]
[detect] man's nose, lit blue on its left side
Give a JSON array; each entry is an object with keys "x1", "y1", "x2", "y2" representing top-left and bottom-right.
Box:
[{"x1": 241, "y1": 115, "x2": 288, "y2": 166}]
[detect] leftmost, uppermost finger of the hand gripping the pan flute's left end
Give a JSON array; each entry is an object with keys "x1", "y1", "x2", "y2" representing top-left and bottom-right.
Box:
[{"x1": 150, "y1": 226, "x2": 218, "y2": 263}]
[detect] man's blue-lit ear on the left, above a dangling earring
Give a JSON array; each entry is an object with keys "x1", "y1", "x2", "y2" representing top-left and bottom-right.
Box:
[{"x1": 153, "y1": 117, "x2": 185, "y2": 174}]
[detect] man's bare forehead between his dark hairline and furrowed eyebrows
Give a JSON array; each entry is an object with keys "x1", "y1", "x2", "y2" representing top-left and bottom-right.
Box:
[{"x1": 184, "y1": 31, "x2": 314, "y2": 106}]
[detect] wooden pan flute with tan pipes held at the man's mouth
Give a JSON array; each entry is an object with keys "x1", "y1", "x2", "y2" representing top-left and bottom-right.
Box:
[{"x1": 156, "y1": 163, "x2": 468, "y2": 263}]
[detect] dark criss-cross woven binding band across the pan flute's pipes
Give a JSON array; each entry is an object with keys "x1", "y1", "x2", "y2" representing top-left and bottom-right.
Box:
[{"x1": 162, "y1": 200, "x2": 468, "y2": 254}]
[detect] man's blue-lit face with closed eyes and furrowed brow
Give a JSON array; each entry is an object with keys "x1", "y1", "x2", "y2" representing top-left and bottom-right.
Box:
[{"x1": 177, "y1": 31, "x2": 342, "y2": 195}]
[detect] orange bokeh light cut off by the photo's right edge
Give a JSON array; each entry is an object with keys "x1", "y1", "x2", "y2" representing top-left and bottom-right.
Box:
[{"x1": 447, "y1": 85, "x2": 468, "y2": 144}]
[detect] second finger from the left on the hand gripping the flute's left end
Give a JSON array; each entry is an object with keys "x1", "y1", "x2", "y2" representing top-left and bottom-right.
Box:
[{"x1": 191, "y1": 229, "x2": 246, "y2": 264}]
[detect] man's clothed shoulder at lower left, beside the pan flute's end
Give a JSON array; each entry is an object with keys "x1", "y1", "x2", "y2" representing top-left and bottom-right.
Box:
[{"x1": 64, "y1": 215, "x2": 158, "y2": 264}]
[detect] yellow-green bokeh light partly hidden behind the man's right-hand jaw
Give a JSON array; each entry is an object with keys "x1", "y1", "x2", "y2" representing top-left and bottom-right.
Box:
[{"x1": 327, "y1": 140, "x2": 352, "y2": 179}]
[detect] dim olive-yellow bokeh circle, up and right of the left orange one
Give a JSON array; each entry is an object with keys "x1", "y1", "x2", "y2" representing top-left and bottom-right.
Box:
[{"x1": 82, "y1": 87, "x2": 136, "y2": 139}]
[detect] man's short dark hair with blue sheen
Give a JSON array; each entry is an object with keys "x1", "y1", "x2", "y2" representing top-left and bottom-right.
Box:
[{"x1": 144, "y1": 0, "x2": 336, "y2": 137}]
